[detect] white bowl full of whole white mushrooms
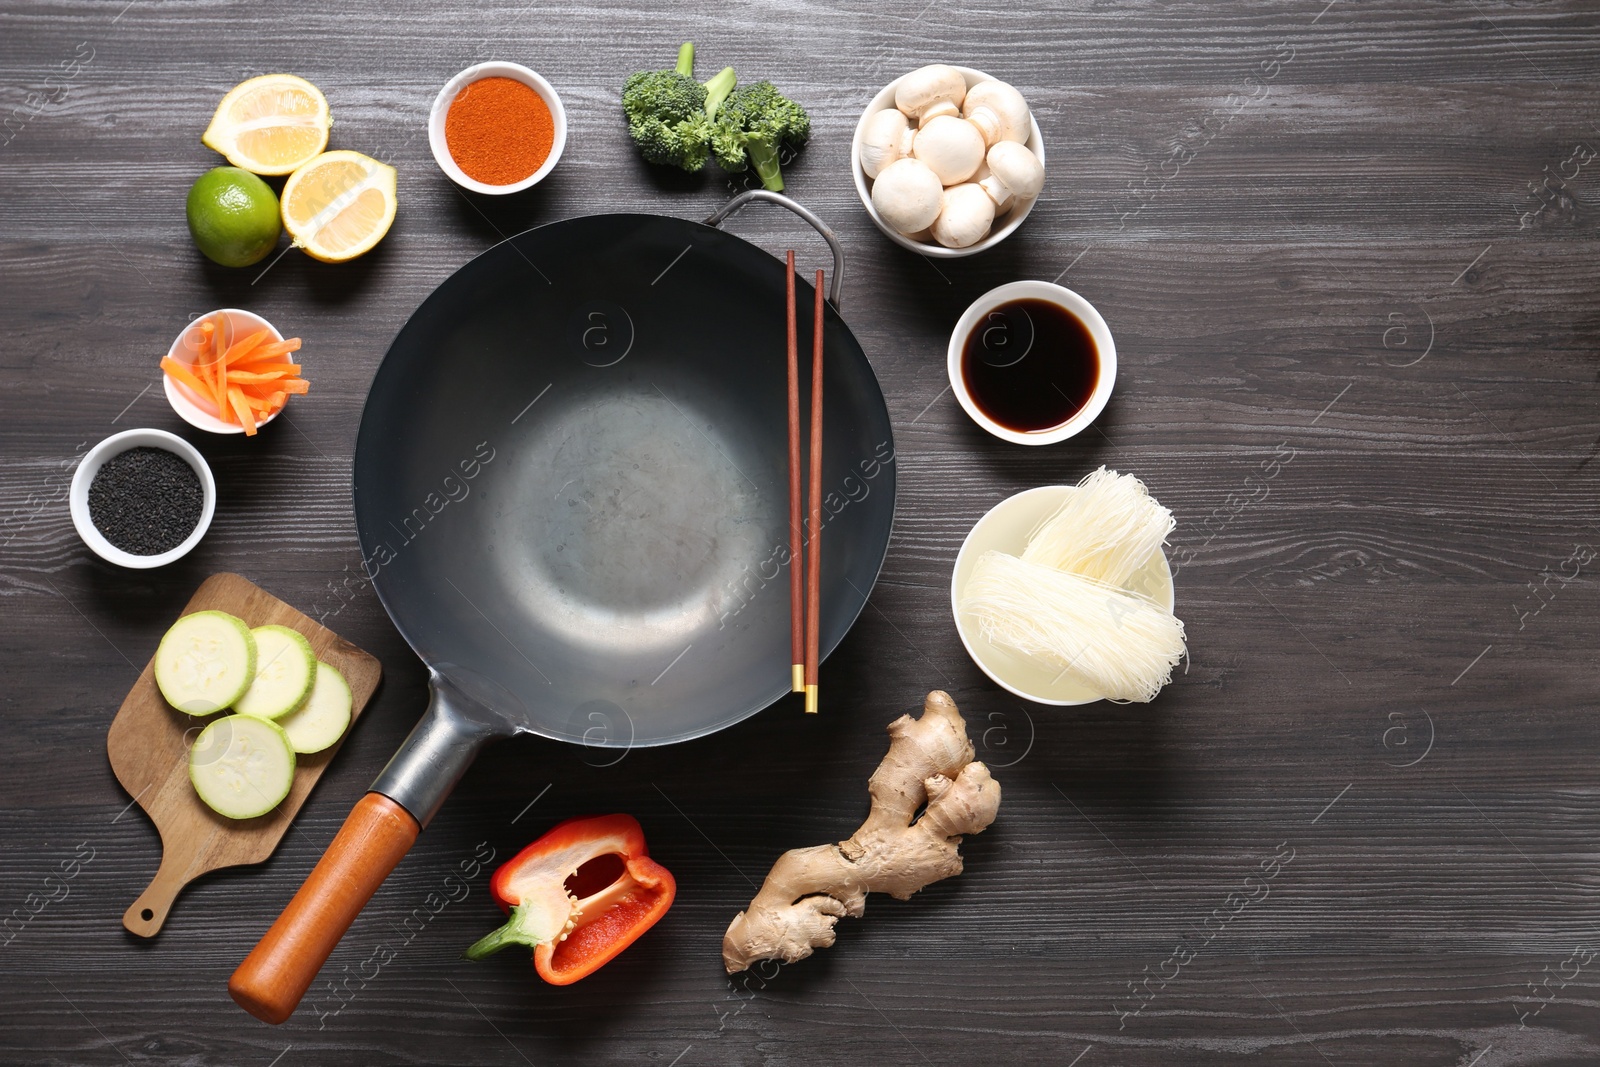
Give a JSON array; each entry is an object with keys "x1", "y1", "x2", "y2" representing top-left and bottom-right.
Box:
[{"x1": 850, "y1": 62, "x2": 1045, "y2": 259}]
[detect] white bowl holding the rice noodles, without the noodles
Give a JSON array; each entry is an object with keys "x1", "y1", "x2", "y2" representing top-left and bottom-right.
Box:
[{"x1": 950, "y1": 485, "x2": 1174, "y2": 705}]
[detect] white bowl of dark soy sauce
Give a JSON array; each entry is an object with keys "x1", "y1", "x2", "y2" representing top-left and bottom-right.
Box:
[{"x1": 949, "y1": 282, "x2": 1117, "y2": 445}]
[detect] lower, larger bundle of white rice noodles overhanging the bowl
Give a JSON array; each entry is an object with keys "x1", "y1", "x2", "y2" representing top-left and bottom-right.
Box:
[{"x1": 962, "y1": 550, "x2": 1184, "y2": 702}]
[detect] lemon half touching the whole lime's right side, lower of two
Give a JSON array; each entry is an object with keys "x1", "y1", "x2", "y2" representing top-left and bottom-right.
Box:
[{"x1": 278, "y1": 152, "x2": 395, "y2": 262}]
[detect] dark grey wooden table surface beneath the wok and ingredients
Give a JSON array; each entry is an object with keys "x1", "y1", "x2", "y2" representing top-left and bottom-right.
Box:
[{"x1": 0, "y1": 0, "x2": 1600, "y2": 1067}]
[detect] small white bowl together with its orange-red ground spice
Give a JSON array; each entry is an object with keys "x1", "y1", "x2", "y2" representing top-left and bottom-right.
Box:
[{"x1": 427, "y1": 61, "x2": 566, "y2": 195}]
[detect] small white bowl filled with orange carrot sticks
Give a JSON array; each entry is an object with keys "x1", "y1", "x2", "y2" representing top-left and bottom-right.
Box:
[{"x1": 162, "y1": 307, "x2": 310, "y2": 437}]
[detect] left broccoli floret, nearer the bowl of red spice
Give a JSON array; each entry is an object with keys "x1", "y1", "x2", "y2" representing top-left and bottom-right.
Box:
[{"x1": 622, "y1": 42, "x2": 736, "y2": 173}]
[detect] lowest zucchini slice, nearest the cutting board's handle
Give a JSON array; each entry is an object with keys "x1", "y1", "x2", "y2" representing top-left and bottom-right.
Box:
[{"x1": 189, "y1": 715, "x2": 294, "y2": 819}]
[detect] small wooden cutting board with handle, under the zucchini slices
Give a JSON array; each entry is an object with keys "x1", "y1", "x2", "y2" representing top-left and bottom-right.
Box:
[{"x1": 106, "y1": 574, "x2": 382, "y2": 937}]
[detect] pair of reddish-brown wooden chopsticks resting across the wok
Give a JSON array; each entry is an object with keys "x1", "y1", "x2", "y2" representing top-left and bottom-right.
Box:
[{"x1": 784, "y1": 250, "x2": 822, "y2": 715}]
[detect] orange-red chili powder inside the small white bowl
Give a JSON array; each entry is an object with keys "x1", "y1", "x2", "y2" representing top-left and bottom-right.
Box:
[{"x1": 445, "y1": 78, "x2": 555, "y2": 186}]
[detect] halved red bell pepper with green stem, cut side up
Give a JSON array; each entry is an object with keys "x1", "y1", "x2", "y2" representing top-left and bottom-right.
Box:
[{"x1": 466, "y1": 814, "x2": 678, "y2": 985}]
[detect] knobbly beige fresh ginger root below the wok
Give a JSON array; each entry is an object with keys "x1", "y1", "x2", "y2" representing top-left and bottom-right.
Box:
[{"x1": 722, "y1": 689, "x2": 1000, "y2": 974}]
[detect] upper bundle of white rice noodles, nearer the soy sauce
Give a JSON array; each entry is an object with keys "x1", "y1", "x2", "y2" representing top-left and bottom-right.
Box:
[{"x1": 1022, "y1": 467, "x2": 1178, "y2": 585}]
